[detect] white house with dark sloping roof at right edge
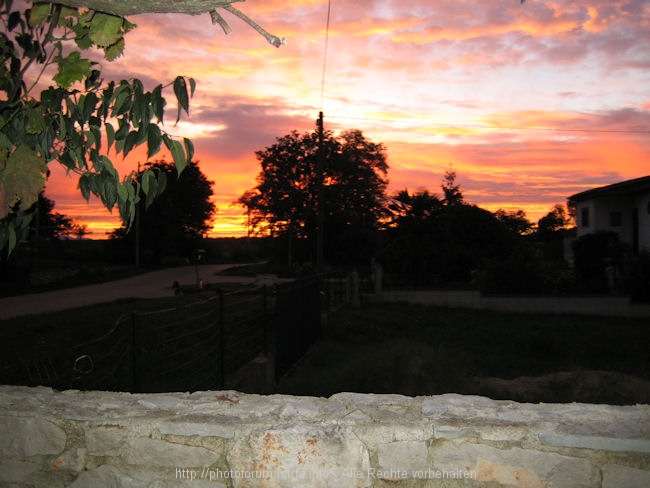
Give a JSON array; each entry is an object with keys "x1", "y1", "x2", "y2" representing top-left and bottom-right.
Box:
[{"x1": 569, "y1": 176, "x2": 650, "y2": 254}]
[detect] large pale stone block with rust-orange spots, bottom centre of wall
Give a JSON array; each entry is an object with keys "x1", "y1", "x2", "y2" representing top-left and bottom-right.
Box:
[{"x1": 227, "y1": 423, "x2": 371, "y2": 488}]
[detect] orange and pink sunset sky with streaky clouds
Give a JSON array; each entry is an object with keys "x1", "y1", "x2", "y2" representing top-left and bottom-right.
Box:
[{"x1": 40, "y1": 0, "x2": 650, "y2": 239}]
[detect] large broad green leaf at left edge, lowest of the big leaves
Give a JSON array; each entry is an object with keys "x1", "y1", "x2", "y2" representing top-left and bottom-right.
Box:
[{"x1": 0, "y1": 144, "x2": 47, "y2": 219}]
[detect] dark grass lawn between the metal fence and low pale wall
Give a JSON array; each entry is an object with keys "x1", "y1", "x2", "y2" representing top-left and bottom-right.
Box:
[{"x1": 279, "y1": 303, "x2": 650, "y2": 403}]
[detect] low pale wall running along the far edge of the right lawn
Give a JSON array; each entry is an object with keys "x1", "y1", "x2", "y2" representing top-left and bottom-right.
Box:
[{"x1": 381, "y1": 290, "x2": 650, "y2": 317}]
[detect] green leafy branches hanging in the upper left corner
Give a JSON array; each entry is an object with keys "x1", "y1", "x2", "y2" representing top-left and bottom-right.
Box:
[{"x1": 0, "y1": 0, "x2": 196, "y2": 252}]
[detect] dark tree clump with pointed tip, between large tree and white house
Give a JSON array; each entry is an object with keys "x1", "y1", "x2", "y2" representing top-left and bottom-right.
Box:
[{"x1": 378, "y1": 179, "x2": 523, "y2": 285}]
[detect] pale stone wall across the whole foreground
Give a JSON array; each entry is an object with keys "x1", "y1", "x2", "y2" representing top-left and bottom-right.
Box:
[{"x1": 0, "y1": 386, "x2": 650, "y2": 488}]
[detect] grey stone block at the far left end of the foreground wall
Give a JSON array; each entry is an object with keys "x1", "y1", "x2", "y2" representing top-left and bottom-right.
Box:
[{"x1": 0, "y1": 416, "x2": 66, "y2": 458}]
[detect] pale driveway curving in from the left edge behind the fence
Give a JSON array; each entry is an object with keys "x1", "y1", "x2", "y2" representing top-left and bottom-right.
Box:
[{"x1": 0, "y1": 264, "x2": 258, "y2": 320}]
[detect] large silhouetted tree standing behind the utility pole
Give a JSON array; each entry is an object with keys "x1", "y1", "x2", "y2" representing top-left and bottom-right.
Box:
[{"x1": 238, "y1": 130, "x2": 388, "y2": 261}]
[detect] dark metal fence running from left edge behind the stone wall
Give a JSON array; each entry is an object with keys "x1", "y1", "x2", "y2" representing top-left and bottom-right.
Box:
[{"x1": 0, "y1": 276, "x2": 347, "y2": 392}]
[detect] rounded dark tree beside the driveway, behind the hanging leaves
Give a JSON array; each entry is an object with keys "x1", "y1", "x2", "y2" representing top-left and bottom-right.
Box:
[{"x1": 111, "y1": 161, "x2": 216, "y2": 263}]
